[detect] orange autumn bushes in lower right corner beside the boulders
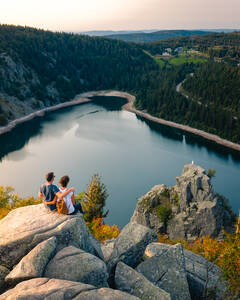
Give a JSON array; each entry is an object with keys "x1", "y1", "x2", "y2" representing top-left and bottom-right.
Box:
[{"x1": 158, "y1": 233, "x2": 240, "y2": 299}]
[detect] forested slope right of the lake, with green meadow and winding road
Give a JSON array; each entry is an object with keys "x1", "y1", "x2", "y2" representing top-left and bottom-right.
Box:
[{"x1": 134, "y1": 32, "x2": 240, "y2": 143}]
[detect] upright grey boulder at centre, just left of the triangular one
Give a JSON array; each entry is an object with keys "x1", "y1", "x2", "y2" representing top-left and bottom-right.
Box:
[{"x1": 108, "y1": 222, "x2": 157, "y2": 273}]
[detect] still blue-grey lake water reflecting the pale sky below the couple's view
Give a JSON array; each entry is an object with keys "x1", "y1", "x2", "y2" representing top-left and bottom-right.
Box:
[{"x1": 0, "y1": 97, "x2": 240, "y2": 227}]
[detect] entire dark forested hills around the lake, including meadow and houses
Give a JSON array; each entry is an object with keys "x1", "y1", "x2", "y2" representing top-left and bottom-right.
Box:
[{"x1": 0, "y1": 25, "x2": 240, "y2": 143}]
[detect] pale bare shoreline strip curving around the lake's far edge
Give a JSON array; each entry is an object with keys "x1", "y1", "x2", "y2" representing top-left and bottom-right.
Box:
[{"x1": 0, "y1": 90, "x2": 240, "y2": 151}]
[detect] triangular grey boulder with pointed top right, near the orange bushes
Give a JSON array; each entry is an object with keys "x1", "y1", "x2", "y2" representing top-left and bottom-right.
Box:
[{"x1": 136, "y1": 244, "x2": 191, "y2": 300}]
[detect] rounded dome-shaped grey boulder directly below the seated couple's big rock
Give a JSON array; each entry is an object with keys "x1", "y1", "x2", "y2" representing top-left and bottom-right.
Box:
[{"x1": 45, "y1": 246, "x2": 108, "y2": 287}]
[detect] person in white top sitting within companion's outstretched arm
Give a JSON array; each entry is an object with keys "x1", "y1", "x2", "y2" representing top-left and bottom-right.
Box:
[{"x1": 59, "y1": 175, "x2": 83, "y2": 215}]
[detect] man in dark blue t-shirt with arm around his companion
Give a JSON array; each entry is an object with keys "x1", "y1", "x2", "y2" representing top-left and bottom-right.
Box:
[{"x1": 38, "y1": 172, "x2": 75, "y2": 210}]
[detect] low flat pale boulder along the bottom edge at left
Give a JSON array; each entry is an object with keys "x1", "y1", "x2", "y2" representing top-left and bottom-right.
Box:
[{"x1": 0, "y1": 278, "x2": 139, "y2": 300}]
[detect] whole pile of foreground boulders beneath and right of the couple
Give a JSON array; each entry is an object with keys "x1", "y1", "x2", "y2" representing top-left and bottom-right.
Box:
[{"x1": 0, "y1": 200, "x2": 225, "y2": 300}]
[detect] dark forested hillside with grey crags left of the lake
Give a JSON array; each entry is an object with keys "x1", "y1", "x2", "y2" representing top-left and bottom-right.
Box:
[{"x1": 0, "y1": 25, "x2": 158, "y2": 123}]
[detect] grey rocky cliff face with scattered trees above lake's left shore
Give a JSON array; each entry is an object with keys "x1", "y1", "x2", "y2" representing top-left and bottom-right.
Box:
[{"x1": 0, "y1": 53, "x2": 59, "y2": 126}]
